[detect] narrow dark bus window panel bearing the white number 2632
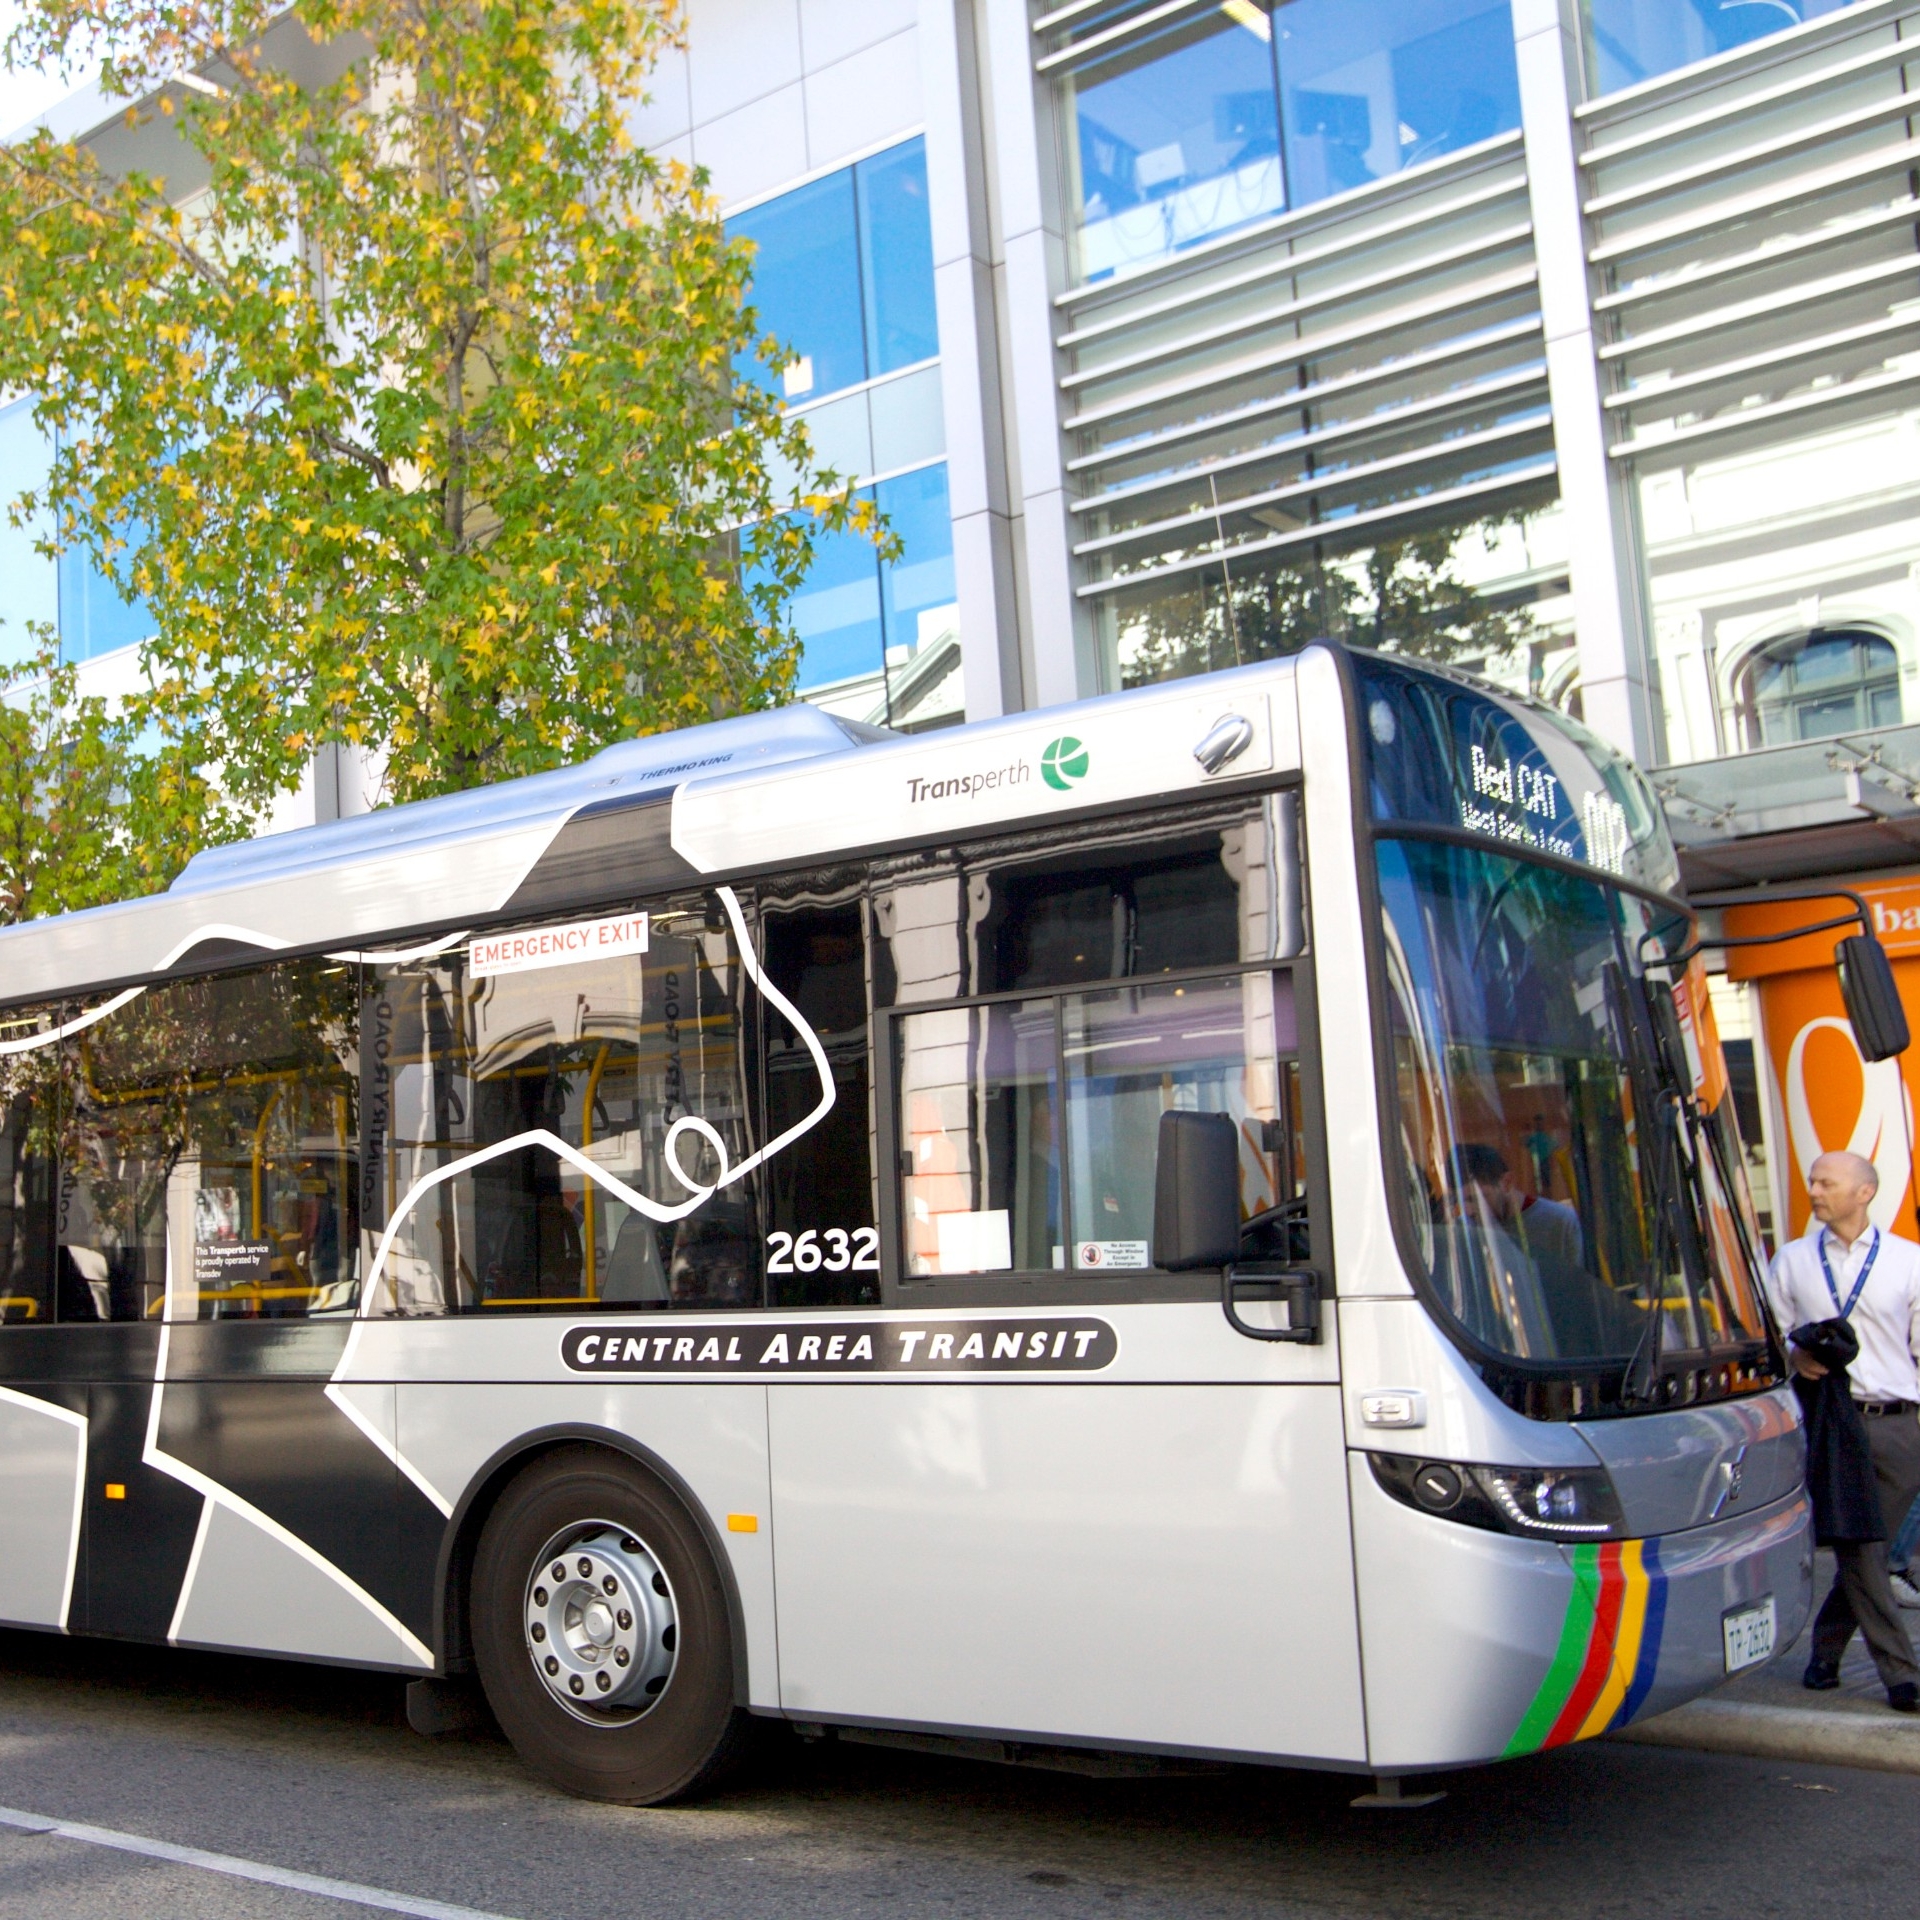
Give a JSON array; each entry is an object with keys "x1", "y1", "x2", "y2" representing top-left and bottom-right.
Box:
[{"x1": 760, "y1": 889, "x2": 879, "y2": 1308}]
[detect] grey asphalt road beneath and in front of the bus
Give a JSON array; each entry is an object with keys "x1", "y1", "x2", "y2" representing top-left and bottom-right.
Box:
[{"x1": 0, "y1": 1634, "x2": 1920, "y2": 1920}]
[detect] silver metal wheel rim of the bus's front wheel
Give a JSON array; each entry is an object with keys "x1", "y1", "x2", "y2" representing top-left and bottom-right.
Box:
[{"x1": 520, "y1": 1521, "x2": 680, "y2": 1726}]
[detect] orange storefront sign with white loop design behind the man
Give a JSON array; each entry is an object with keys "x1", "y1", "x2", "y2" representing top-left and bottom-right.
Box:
[{"x1": 1726, "y1": 877, "x2": 1920, "y2": 1235}]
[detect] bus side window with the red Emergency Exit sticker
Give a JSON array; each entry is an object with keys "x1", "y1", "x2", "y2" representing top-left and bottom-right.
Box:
[{"x1": 365, "y1": 895, "x2": 760, "y2": 1315}]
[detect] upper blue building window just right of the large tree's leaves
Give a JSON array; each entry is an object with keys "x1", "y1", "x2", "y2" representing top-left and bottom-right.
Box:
[{"x1": 728, "y1": 140, "x2": 939, "y2": 405}]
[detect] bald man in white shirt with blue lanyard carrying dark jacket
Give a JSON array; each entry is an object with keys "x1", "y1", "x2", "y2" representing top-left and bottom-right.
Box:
[{"x1": 1766, "y1": 1154, "x2": 1920, "y2": 1713}]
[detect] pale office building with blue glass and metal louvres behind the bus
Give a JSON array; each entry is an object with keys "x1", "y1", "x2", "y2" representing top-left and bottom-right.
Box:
[{"x1": 0, "y1": 0, "x2": 1920, "y2": 1221}]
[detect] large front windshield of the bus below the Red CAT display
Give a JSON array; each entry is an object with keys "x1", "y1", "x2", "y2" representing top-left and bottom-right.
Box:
[{"x1": 1375, "y1": 837, "x2": 1770, "y2": 1411}]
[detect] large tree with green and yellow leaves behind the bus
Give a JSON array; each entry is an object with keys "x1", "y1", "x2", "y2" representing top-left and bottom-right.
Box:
[{"x1": 0, "y1": 0, "x2": 877, "y2": 856}]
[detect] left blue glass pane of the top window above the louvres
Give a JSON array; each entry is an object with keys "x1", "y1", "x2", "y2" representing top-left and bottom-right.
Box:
[{"x1": 1073, "y1": 0, "x2": 1284, "y2": 280}]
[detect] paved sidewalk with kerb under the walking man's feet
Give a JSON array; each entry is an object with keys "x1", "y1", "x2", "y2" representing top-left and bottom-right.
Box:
[{"x1": 1611, "y1": 1551, "x2": 1920, "y2": 1774}]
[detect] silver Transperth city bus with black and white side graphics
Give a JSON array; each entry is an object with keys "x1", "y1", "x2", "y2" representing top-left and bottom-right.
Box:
[{"x1": 0, "y1": 647, "x2": 1812, "y2": 1801}]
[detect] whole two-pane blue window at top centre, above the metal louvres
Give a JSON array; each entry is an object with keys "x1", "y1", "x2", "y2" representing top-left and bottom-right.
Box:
[{"x1": 1048, "y1": 0, "x2": 1521, "y2": 280}]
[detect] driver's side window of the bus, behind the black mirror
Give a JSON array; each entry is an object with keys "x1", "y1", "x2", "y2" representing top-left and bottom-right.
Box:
[{"x1": 874, "y1": 795, "x2": 1311, "y2": 1281}]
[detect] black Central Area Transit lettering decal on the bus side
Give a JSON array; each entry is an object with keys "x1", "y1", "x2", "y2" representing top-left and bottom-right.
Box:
[{"x1": 561, "y1": 1317, "x2": 1119, "y2": 1379}]
